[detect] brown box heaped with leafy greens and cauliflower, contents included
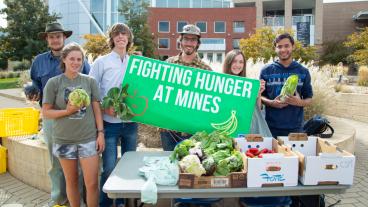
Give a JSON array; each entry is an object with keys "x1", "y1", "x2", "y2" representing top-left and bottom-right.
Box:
[{"x1": 170, "y1": 131, "x2": 246, "y2": 188}]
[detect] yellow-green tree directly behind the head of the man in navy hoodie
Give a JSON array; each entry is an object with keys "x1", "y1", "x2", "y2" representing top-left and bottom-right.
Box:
[{"x1": 239, "y1": 27, "x2": 317, "y2": 63}]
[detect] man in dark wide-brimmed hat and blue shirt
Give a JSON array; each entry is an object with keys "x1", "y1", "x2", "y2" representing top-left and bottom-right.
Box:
[{"x1": 30, "y1": 22, "x2": 90, "y2": 206}]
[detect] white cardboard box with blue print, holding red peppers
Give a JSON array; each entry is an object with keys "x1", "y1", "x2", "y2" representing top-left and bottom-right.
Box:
[{"x1": 235, "y1": 135, "x2": 298, "y2": 187}]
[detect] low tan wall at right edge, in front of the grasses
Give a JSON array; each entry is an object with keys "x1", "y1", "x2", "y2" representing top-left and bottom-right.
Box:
[{"x1": 325, "y1": 93, "x2": 368, "y2": 123}]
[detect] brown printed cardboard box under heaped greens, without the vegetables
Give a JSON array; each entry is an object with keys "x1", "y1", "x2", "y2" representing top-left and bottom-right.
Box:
[{"x1": 178, "y1": 154, "x2": 247, "y2": 188}]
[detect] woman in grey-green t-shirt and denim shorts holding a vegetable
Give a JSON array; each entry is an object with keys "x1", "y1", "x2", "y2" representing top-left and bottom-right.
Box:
[{"x1": 42, "y1": 43, "x2": 105, "y2": 207}]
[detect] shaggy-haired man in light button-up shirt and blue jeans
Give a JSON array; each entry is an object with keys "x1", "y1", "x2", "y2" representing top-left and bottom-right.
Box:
[{"x1": 89, "y1": 23, "x2": 138, "y2": 207}]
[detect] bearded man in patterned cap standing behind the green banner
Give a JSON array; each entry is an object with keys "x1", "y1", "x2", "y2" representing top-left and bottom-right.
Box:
[{"x1": 160, "y1": 24, "x2": 212, "y2": 151}]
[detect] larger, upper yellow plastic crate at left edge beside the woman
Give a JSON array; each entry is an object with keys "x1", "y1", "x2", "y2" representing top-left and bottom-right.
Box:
[{"x1": 0, "y1": 108, "x2": 40, "y2": 137}]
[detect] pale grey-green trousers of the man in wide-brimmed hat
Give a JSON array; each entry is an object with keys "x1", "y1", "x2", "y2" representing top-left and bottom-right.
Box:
[{"x1": 42, "y1": 118, "x2": 83, "y2": 205}]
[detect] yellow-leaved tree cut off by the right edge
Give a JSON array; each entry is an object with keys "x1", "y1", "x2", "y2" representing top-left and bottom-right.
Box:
[{"x1": 344, "y1": 27, "x2": 368, "y2": 65}]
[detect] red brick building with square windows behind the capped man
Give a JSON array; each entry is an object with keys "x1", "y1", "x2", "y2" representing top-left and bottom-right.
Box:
[{"x1": 148, "y1": 7, "x2": 256, "y2": 63}]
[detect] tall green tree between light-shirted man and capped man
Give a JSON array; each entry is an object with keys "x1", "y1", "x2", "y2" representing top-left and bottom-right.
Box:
[{"x1": 119, "y1": 0, "x2": 156, "y2": 58}]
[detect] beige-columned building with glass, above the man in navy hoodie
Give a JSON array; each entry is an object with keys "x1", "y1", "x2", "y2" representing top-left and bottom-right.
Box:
[{"x1": 233, "y1": 0, "x2": 323, "y2": 45}]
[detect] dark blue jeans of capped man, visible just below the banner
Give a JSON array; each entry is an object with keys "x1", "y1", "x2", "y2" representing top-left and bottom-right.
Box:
[{"x1": 160, "y1": 130, "x2": 192, "y2": 151}]
